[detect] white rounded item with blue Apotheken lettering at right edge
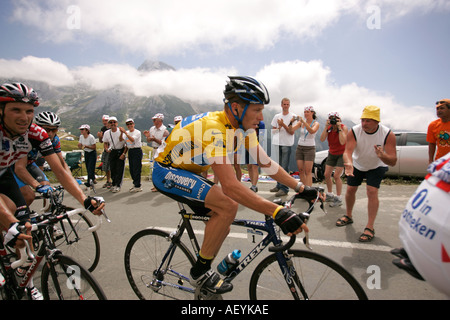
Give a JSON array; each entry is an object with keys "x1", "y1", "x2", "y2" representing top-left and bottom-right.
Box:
[{"x1": 399, "y1": 153, "x2": 450, "y2": 297}]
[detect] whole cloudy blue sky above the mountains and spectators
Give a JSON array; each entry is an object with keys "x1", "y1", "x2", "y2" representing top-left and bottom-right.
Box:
[{"x1": 0, "y1": 0, "x2": 450, "y2": 130}]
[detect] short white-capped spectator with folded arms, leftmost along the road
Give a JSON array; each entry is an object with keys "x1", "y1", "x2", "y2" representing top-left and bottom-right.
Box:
[{"x1": 78, "y1": 124, "x2": 97, "y2": 187}]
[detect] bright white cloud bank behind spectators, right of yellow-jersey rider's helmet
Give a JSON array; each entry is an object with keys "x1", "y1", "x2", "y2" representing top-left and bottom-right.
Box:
[{"x1": 256, "y1": 60, "x2": 436, "y2": 131}]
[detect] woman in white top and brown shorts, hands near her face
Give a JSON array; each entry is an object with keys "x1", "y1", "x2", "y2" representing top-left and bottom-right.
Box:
[{"x1": 292, "y1": 106, "x2": 320, "y2": 186}]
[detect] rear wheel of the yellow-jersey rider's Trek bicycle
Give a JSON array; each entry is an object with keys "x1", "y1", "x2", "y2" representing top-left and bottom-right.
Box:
[{"x1": 125, "y1": 229, "x2": 195, "y2": 300}]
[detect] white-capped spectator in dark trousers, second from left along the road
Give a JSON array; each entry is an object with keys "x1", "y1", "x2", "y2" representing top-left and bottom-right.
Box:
[{"x1": 103, "y1": 117, "x2": 128, "y2": 193}]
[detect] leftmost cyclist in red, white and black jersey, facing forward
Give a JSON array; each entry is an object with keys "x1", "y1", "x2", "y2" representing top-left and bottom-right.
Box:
[{"x1": 0, "y1": 83, "x2": 105, "y2": 247}]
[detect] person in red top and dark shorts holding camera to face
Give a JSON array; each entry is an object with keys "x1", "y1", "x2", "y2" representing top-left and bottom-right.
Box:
[{"x1": 320, "y1": 112, "x2": 348, "y2": 207}]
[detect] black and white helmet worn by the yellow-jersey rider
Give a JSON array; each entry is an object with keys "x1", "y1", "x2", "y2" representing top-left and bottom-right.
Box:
[{"x1": 223, "y1": 76, "x2": 270, "y2": 104}]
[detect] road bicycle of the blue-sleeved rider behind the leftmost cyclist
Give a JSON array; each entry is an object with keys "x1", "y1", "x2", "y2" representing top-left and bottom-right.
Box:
[{"x1": 31, "y1": 184, "x2": 104, "y2": 272}]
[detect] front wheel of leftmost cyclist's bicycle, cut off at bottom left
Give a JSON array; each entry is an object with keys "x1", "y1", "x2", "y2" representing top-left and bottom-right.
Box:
[{"x1": 41, "y1": 254, "x2": 106, "y2": 300}]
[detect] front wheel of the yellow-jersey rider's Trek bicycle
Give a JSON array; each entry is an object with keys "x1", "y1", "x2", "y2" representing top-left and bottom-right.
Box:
[{"x1": 249, "y1": 250, "x2": 367, "y2": 300}]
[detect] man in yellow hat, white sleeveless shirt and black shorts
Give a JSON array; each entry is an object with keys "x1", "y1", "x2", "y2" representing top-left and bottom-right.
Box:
[{"x1": 336, "y1": 106, "x2": 397, "y2": 242}]
